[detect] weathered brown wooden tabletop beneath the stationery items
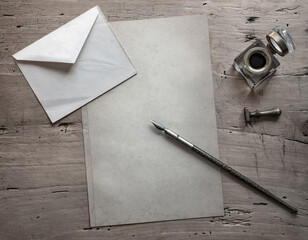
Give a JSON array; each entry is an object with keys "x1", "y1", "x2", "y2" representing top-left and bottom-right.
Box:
[{"x1": 0, "y1": 0, "x2": 308, "y2": 240}]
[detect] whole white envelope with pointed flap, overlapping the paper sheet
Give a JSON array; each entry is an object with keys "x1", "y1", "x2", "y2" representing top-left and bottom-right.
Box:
[{"x1": 13, "y1": 6, "x2": 136, "y2": 122}]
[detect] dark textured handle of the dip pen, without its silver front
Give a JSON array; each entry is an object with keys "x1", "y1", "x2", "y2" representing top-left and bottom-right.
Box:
[{"x1": 192, "y1": 145, "x2": 298, "y2": 214}]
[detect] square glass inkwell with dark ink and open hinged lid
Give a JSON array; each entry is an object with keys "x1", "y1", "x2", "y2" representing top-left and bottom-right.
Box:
[{"x1": 233, "y1": 27, "x2": 295, "y2": 89}]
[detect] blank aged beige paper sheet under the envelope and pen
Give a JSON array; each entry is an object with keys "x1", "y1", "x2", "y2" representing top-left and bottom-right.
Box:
[{"x1": 83, "y1": 15, "x2": 223, "y2": 226}]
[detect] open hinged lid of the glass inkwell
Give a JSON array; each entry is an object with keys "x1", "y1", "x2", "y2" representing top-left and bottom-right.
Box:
[{"x1": 266, "y1": 27, "x2": 295, "y2": 56}]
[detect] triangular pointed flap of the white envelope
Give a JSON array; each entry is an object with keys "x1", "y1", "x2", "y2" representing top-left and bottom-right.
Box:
[{"x1": 13, "y1": 7, "x2": 99, "y2": 64}]
